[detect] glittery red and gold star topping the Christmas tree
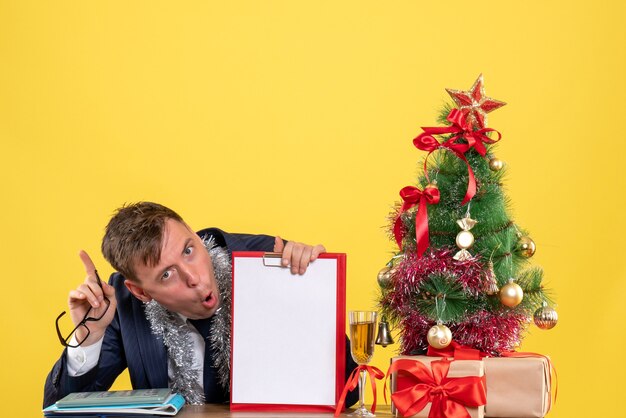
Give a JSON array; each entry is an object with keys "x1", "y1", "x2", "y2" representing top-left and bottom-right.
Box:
[{"x1": 446, "y1": 74, "x2": 506, "y2": 129}]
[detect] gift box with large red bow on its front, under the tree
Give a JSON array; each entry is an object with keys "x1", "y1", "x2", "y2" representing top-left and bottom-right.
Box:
[{"x1": 389, "y1": 356, "x2": 486, "y2": 418}]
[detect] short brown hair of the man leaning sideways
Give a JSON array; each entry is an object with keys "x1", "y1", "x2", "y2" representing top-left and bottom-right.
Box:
[{"x1": 102, "y1": 202, "x2": 184, "y2": 281}]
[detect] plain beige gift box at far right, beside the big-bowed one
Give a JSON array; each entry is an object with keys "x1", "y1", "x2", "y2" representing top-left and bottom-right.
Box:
[{"x1": 483, "y1": 356, "x2": 551, "y2": 418}]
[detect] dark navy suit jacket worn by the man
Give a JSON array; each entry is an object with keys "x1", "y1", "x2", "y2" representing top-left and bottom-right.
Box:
[{"x1": 43, "y1": 228, "x2": 358, "y2": 407}]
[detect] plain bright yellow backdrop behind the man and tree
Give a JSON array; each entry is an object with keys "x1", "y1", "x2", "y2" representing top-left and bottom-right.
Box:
[{"x1": 0, "y1": 0, "x2": 626, "y2": 417}]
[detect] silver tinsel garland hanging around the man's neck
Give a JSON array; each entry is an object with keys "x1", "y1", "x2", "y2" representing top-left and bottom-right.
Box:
[{"x1": 144, "y1": 237, "x2": 232, "y2": 405}]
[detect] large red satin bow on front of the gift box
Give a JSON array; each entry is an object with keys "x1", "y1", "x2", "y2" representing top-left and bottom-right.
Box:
[{"x1": 387, "y1": 359, "x2": 487, "y2": 418}]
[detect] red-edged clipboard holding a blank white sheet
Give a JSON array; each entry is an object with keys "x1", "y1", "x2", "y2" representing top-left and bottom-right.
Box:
[{"x1": 230, "y1": 252, "x2": 346, "y2": 412}]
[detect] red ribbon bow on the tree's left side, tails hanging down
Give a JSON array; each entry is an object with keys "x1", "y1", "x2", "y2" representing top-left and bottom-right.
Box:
[{"x1": 393, "y1": 184, "x2": 439, "y2": 257}]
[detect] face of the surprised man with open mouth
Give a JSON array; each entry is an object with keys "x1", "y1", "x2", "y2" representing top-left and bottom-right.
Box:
[{"x1": 127, "y1": 219, "x2": 220, "y2": 319}]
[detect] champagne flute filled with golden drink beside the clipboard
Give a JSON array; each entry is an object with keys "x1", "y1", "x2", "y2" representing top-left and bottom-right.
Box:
[{"x1": 348, "y1": 311, "x2": 376, "y2": 417}]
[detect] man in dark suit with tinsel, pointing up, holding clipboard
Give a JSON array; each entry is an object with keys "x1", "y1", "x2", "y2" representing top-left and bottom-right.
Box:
[{"x1": 44, "y1": 202, "x2": 358, "y2": 407}]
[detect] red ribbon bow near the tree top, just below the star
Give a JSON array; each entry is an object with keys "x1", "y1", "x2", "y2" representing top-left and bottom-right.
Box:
[{"x1": 413, "y1": 109, "x2": 502, "y2": 205}]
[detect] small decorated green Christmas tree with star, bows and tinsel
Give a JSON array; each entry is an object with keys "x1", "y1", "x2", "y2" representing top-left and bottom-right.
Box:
[{"x1": 378, "y1": 75, "x2": 557, "y2": 356}]
